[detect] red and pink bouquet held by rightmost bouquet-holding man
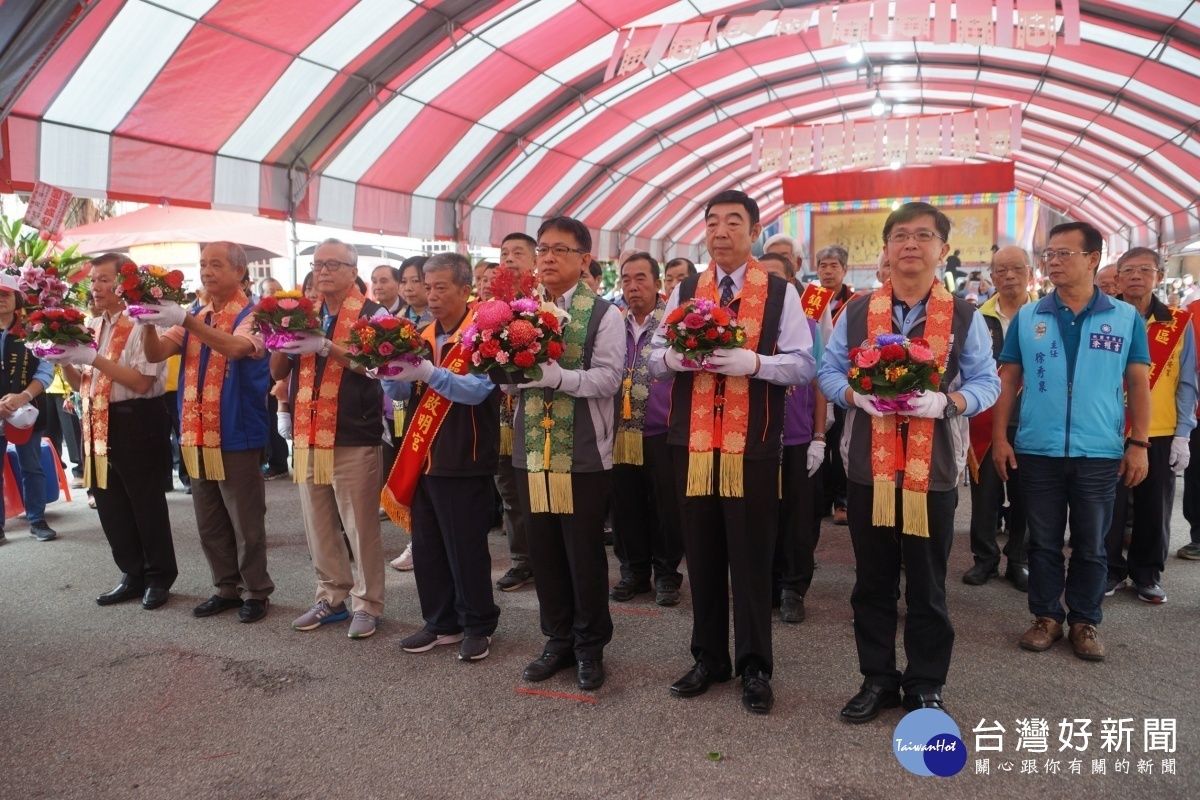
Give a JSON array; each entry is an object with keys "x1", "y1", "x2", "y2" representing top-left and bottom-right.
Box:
[{"x1": 846, "y1": 333, "x2": 946, "y2": 411}]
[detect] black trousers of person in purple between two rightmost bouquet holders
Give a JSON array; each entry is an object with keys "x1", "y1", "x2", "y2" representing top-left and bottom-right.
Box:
[{"x1": 770, "y1": 444, "x2": 820, "y2": 597}]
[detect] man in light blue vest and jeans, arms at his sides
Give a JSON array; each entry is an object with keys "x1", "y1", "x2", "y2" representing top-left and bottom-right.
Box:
[{"x1": 991, "y1": 222, "x2": 1151, "y2": 661}]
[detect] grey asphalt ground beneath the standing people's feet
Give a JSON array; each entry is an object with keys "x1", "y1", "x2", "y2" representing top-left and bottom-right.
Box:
[{"x1": 0, "y1": 470, "x2": 1200, "y2": 800}]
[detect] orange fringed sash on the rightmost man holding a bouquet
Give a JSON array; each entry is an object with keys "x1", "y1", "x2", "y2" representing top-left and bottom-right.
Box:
[{"x1": 866, "y1": 281, "x2": 954, "y2": 537}]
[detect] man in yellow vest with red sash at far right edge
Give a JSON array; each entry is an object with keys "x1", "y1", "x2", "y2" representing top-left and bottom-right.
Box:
[{"x1": 1104, "y1": 247, "x2": 1196, "y2": 604}]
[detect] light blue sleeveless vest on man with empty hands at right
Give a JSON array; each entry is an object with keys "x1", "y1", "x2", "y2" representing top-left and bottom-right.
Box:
[{"x1": 1009, "y1": 294, "x2": 1146, "y2": 458}]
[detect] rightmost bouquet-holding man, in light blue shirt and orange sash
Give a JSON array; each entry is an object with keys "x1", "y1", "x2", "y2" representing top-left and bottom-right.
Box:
[{"x1": 817, "y1": 203, "x2": 1000, "y2": 723}]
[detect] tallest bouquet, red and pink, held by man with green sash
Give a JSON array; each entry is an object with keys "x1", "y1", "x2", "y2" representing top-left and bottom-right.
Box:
[{"x1": 462, "y1": 270, "x2": 565, "y2": 384}]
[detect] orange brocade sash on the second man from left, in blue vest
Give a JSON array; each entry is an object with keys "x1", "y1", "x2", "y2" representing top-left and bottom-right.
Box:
[{"x1": 179, "y1": 291, "x2": 250, "y2": 481}]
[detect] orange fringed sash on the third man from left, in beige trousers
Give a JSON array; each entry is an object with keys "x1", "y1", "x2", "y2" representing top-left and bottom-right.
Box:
[{"x1": 292, "y1": 287, "x2": 365, "y2": 486}]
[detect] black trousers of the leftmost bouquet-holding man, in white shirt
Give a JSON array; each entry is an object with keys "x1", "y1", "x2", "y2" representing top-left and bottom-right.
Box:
[{"x1": 91, "y1": 397, "x2": 179, "y2": 589}]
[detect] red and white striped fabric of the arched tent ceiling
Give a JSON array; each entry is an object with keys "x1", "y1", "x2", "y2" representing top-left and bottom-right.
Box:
[{"x1": 0, "y1": 0, "x2": 1200, "y2": 257}]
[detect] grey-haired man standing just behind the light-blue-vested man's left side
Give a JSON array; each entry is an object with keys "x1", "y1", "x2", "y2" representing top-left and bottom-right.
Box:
[{"x1": 962, "y1": 247, "x2": 1034, "y2": 591}]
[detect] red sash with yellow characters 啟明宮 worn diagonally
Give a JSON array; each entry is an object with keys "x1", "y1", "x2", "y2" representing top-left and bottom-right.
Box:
[{"x1": 379, "y1": 312, "x2": 474, "y2": 533}]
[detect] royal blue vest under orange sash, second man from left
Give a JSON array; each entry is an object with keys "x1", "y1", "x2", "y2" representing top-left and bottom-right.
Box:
[{"x1": 179, "y1": 305, "x2": 271, "y2": 450}]
